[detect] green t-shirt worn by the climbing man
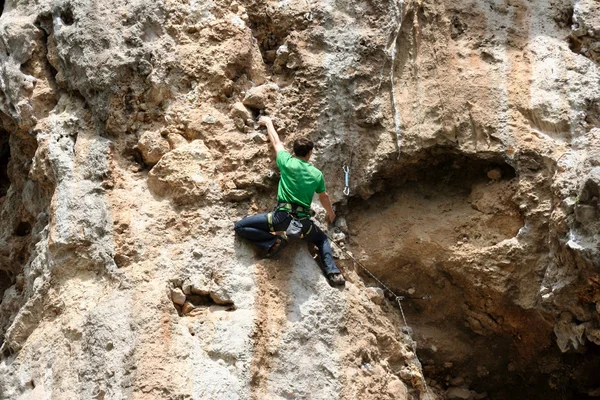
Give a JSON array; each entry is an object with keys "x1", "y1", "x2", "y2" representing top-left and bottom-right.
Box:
[{"x1": 277, "y1": 150, "x2": 325, "y2": 208}]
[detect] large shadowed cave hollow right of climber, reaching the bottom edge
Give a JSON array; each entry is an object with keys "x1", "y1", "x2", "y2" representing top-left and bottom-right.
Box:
[{"x1": 346, "y1": 148, "x2": 600, "y2": 400}]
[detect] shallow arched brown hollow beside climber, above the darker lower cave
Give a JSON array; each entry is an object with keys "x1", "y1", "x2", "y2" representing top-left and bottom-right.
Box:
[{"x1": 348, "y1": 153, "x2": 523, "y2": 272}]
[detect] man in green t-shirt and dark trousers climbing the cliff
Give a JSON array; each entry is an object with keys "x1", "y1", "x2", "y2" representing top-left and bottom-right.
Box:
[{"x1": 234, "y1": 116, "x2": 346, "y2": 286}]
